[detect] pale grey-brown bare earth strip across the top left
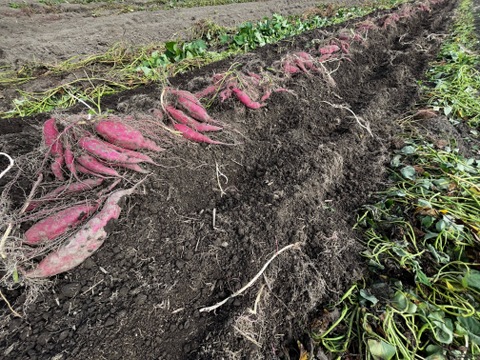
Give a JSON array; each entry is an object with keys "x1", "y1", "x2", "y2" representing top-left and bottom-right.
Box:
[{"x1": 0, "y1": 0, "x2": 362, "y2": 67}]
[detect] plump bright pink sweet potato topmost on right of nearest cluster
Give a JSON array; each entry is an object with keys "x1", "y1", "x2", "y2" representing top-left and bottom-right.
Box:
[{"x1": 95, "y1": 119, "x2": 164, "y2": 151}]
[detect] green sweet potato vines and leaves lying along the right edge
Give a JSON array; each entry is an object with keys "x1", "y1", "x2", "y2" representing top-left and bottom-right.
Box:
[{"x1": 312, "y1": 0, "x2": 480, "y2": 360}]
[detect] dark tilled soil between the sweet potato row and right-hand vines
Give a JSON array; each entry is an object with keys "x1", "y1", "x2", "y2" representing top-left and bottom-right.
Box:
[{"x1": 0, "y1": 2, "x2": 455, "y2": 360}]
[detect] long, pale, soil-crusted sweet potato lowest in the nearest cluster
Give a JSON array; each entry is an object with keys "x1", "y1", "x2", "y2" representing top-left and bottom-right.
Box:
[{"x1": 25, "y1": 188, "x2": 134, "y2": 278}]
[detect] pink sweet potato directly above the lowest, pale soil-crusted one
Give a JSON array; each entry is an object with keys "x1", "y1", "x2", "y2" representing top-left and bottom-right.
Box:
[{"x1": 23, "y1": 204, "x2": 98, "y2": 245}]
